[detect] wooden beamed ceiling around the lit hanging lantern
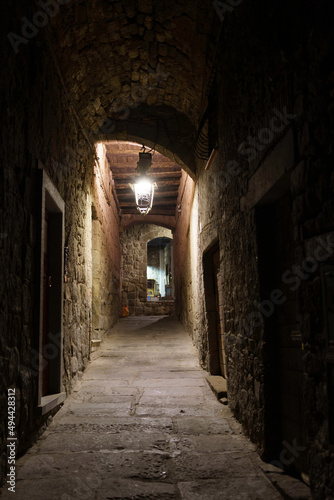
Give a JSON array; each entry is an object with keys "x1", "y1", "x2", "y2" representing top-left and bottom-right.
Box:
[{"x1": 105, "y1": 142, "x2": 182, "y2": 217}]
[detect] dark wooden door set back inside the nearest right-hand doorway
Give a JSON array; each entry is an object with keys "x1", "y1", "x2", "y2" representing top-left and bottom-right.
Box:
[{"x1": 274, "y1": 195, "x2": 307, "y2": 473}]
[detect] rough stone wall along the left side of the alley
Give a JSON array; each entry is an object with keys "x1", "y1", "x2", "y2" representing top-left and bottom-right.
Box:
[{"x1": 0, "y1": 6, "x2": 120, "y2": 481}]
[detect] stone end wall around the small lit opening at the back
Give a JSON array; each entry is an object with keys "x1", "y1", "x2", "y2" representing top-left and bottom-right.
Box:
[{"x1": 122, "y1": 224, "x2": 174, "y2": 316}]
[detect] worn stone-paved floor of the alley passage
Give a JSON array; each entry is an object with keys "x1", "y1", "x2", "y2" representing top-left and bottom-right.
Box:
[{"x1": 2, "y1": 317, "x2": 281, "y2": 500}]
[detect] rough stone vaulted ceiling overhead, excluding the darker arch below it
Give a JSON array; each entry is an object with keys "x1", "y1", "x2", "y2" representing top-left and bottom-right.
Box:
[{"x1": 52, "y1": 0, "x2": 221, "y2": 126}]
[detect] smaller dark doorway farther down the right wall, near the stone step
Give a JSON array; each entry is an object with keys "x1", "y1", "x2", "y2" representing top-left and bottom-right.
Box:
[{"x1": 203, "y1": 242, "x2": 226, "y2": 378}]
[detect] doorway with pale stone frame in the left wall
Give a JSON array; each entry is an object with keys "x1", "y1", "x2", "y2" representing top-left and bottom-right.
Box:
[{"x1": 38, "y1": 170, "x2": 65, "y2": 415}]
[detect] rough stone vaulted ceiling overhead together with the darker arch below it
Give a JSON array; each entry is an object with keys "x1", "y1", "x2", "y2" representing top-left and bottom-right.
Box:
[{"x1": 49, "y1": 0, "x2": 221, "y2": 179}]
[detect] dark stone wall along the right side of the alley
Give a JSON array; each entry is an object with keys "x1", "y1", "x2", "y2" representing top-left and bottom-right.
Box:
[{"x1": 218, "y1": 6, "x2": 334, "y2": 499}]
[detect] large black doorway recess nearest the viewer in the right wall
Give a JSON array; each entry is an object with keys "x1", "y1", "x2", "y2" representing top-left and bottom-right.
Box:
[{"x1": 256, "y1": 194, "x2": 308, "y2": 476}]
